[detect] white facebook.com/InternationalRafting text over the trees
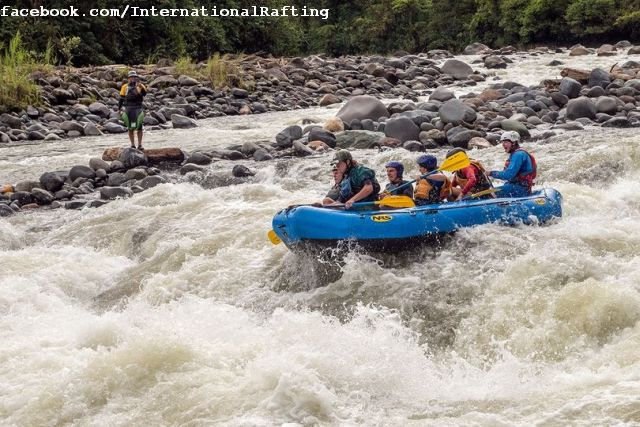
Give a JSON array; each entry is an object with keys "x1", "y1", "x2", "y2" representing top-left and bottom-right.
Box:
[{"x1": 0, "y1": 5, "x2": 329, "y2": 19}]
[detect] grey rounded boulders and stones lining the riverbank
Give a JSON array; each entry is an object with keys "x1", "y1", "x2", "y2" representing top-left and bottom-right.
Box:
[{"x1": 0, "y1": 42, "x2": 640, "y2": 216}]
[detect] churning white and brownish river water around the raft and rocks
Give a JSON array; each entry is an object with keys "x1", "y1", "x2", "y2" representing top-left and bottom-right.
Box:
[{"x1": 0, "y1": 54, "x2": 640, "y2": 426}]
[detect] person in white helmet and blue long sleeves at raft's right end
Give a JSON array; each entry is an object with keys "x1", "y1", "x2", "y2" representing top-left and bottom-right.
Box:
[{"x1": 489, "y1": 131, "x2": 538, "y2": 197}]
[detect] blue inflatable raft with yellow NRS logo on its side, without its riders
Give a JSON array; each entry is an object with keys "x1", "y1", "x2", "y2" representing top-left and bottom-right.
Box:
[{"x1": 273, "y1": 188, "x2": 562, "y2": 252}]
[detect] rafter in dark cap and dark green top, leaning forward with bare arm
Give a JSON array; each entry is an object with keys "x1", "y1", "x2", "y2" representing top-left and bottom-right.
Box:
[{"x1": 334, "y1": 150, "x2": 380, "y2": 209}]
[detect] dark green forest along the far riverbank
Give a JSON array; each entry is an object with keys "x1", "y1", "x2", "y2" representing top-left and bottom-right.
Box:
[{"x1": 0, "y1": 0, "x2": 640, "y2": 66}]
